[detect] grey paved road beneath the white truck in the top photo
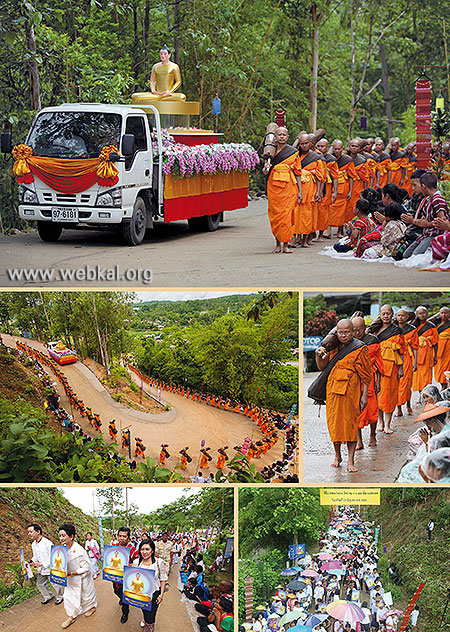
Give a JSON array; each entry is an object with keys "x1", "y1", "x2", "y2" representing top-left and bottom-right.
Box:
[{"x1": 0, "y1": 199, "x2": 444, "y2": 289}]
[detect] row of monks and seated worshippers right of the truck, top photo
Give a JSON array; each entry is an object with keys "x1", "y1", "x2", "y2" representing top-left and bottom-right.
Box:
[{"x1": 263, "y1": 127, "x2": 450, "y2": 269}]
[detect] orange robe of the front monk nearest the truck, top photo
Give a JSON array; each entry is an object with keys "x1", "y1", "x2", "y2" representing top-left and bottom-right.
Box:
[{"x1": 267, "y1": 152, "x2": 302, "y2": 243}]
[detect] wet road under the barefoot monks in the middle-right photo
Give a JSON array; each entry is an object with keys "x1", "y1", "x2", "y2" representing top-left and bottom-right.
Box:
[{"x1": 303, "y1": 373, "x2": 421, "y2": 485}]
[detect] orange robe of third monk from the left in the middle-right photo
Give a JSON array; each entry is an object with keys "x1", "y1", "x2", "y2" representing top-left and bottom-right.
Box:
[{"x1": 378, "y1": 325, "x2": 406, "y2": 413}]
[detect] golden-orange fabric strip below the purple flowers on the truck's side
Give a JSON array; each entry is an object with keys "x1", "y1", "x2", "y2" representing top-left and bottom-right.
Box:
[{"x1": 164, "y1": 171, "x2": 248, "y2": 200}]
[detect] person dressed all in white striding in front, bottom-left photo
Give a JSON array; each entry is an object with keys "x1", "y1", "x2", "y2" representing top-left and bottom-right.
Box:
[{"x1": 59, "y1": 523, "x2": 97, "y2": 628}]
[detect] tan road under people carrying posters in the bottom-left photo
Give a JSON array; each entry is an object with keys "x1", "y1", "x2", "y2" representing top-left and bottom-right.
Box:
[{"x1": 0, "y1": 556, "x2": 194, "y2": 632}]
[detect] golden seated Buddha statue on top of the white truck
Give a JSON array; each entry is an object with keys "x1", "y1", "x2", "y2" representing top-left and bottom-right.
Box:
[{"x1": 132, "y1": 46, "x2": 186, "y2": 103}]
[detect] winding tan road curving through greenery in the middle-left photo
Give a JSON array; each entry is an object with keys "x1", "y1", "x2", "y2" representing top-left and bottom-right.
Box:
[{"x1": 2, "y1": 334, "x2": 283, "y2": 476}]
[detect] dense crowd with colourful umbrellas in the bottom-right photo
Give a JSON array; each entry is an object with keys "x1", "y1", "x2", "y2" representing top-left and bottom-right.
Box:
[{"x1": 240, "y1": 507, "x2": 419, "y2": 632}]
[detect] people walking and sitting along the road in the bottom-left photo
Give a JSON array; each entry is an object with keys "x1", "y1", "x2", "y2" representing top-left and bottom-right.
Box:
[{"x1": 27, "y1": 523, "x2": 234, "y2": 632}]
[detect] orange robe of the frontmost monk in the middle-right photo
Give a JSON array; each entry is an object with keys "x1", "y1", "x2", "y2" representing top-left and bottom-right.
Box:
[{"x1": 326, "y1": 345, "x2": 372, "y2": 443}]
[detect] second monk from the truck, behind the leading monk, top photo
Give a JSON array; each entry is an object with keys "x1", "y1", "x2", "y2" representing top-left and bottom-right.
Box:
[{"x1": 294, "y1": 134, "x2": 326, "y2": 248}]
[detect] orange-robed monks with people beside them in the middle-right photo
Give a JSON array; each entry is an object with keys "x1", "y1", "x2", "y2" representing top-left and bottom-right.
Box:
[{"x1": 308, "y1": 305, "x2": 450, "y2": 474}]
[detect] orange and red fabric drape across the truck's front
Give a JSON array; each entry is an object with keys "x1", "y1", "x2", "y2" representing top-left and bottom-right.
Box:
[{"x1": 12, "y1": 145, "x2": 119, "y2": 193}]
